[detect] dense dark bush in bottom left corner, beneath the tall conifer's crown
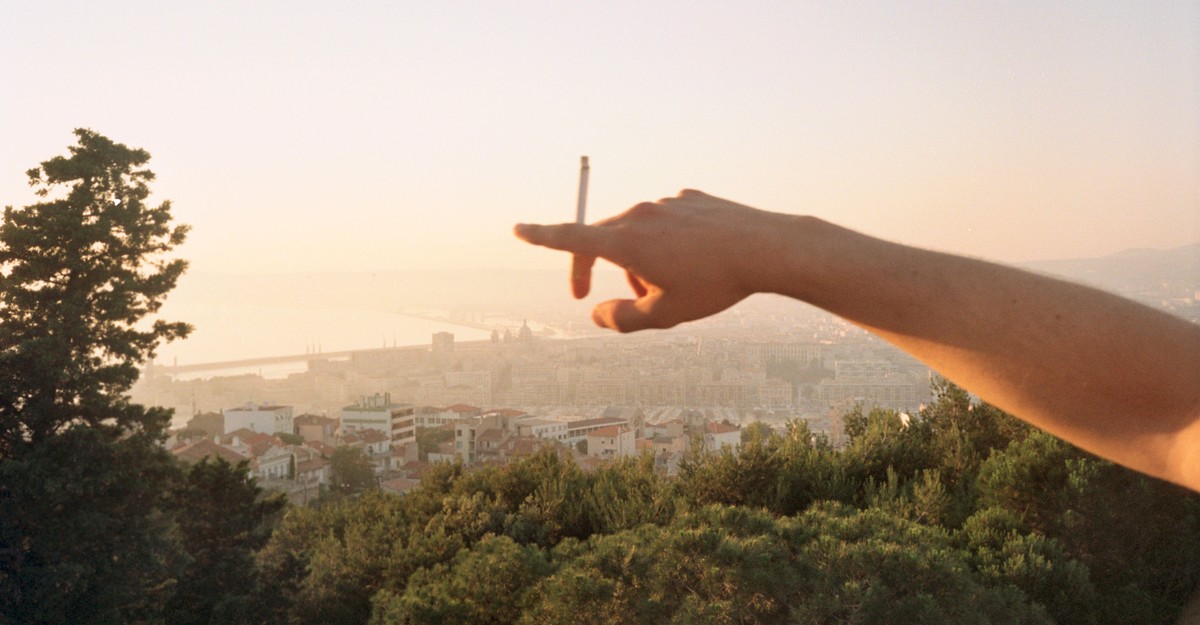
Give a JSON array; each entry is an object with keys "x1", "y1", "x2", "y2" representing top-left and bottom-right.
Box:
[{"x1": 0, "y1": 427, "x2": 186, "y2": 624}]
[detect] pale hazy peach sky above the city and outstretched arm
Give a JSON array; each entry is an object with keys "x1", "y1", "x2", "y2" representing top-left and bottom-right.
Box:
[{"x1": 0, "y1": 0, "x2": 1200, "y2": 272}]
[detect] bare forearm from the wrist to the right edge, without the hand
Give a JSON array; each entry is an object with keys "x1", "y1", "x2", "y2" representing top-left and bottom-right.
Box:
[{"x1": 762, "y1": 217, "x2": 1200, "y2": 488}]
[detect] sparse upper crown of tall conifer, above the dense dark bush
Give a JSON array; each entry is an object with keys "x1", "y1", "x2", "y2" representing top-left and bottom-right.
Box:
[{"x1": 0, "y1": 130, "x2": 190, "y2": 448}]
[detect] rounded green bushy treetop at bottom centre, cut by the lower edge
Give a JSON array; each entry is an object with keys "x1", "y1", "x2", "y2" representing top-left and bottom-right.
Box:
[{"x1": 522, "y1": 509, "x2": 805, "y2": 624}]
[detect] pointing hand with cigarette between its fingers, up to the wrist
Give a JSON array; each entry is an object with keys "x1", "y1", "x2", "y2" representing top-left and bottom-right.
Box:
[{"x1": 514, "y1": 191, "x2": 787, "y2": 332}]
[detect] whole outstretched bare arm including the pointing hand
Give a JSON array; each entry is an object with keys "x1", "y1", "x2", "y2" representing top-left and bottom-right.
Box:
[{"x1": 515, "y1": 191, "x2": 1200, "y2": 491}]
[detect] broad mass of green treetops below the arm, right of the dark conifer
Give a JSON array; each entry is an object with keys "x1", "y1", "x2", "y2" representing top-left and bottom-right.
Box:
[{"x1": 259, "y1": 385, "x2": 1200, "y2": 624}]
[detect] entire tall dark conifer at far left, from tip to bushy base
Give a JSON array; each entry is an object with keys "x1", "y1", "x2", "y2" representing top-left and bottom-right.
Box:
[{"x1": 0, "y1": 130, "x2": 188, "y2": 623}]
